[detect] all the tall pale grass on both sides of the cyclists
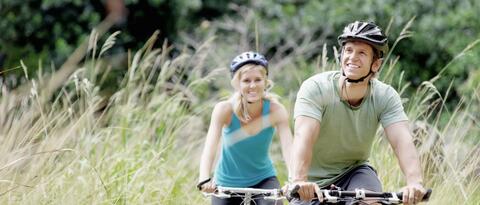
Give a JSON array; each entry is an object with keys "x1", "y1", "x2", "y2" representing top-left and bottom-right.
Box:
[{"x1": 0, "y1": 19, "x2": 480, "y2": 204}]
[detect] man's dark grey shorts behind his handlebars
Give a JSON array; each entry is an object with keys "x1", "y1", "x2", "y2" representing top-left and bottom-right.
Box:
[{"x1": 290, "y1": 165, "x2": 382, "y2": 205}]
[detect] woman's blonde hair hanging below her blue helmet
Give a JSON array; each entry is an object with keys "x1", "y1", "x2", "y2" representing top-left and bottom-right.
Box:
[{"x1": 230, "y1": 64, "x2": 278, "y2": 123}]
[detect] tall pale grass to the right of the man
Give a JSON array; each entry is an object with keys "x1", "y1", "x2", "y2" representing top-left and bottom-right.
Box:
[{"x1": 372, "y1": 22, "x2": 480, "y2": 204}]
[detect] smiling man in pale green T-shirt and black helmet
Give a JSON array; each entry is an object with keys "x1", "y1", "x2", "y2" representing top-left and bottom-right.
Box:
[{"x1": 290, "y1": 21, "x2": 426, "y2": 205}]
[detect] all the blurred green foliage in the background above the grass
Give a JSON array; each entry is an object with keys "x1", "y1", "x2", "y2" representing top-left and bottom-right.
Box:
[{"x1": 0, "y1": 0, "x2": 480, "y2": 101}]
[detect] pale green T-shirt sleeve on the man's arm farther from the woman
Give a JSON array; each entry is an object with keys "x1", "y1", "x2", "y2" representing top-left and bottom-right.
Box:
[{"x1": 380, "y1": 87, "x2": 408, "y2": 128}]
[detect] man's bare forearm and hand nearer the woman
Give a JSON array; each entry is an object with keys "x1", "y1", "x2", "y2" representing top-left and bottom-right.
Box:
[{"x1": 290, "y1": 116, "x2": 321, "y2": 201}]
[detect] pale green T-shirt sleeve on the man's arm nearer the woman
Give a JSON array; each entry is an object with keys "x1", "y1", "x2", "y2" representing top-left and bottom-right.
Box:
[{"x1": 293, "y1": 80, "x2": 324, "y2": 122}]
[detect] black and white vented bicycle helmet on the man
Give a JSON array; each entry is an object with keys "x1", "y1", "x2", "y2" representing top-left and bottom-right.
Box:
[{"x1": 338, "y1": 21, "x2": 388, "y2": 58}]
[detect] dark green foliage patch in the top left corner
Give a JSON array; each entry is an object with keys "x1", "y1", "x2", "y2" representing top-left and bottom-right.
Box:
[{"x1": 0, "y1": 0, "x2": 101, "y2": 74}]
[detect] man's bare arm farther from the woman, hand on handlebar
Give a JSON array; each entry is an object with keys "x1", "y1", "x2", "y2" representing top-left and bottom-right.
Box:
[{"x1": 385, "y1": 121, "x2": 426, "y2": 205}]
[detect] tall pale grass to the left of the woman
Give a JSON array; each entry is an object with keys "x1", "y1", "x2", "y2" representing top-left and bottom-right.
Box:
[{"x1": 0, "y1": 30, "x2": 216, "y2": 204}]
